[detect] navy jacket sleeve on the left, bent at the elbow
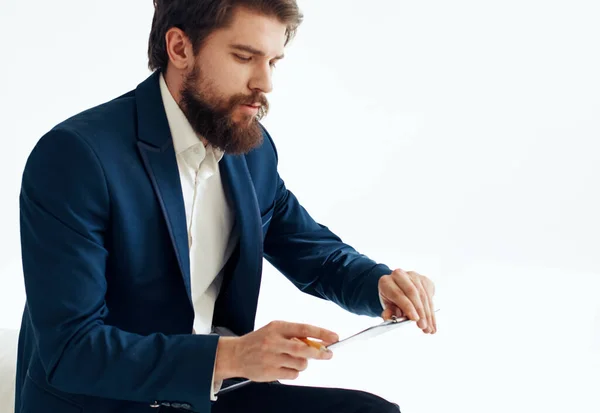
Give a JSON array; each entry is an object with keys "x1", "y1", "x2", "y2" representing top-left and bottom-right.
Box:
[{"x1": 20, "y1": 129, "x2": 218, "y2": 411}]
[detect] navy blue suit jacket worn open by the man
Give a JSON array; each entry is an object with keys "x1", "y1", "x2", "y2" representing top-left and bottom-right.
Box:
[{"x1": 15, "y1": 73, "x2": 391, "y2": 413}]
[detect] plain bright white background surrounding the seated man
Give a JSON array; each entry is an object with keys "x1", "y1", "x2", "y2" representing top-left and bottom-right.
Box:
[{"x1": 0, "y1": 0, "x2": 600, "y2": 413}]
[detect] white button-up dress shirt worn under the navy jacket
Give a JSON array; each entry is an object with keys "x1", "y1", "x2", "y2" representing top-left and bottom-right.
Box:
[{"x1": 160, "y1": 74, "x2": 238, "y2": 400}]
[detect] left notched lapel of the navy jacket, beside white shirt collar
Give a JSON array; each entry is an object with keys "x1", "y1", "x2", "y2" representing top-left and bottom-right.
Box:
[{"x1": 135, "y1": 71, "x2": 192, "y2": 304}]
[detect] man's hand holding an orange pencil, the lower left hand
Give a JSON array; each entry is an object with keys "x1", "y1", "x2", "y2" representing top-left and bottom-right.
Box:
[{"x1": 215, "y1": 321, "x2": 339, "y2": 382}]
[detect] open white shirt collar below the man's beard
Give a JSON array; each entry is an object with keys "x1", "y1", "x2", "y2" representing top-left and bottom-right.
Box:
[{"x1": 159, "y1": 73, "x2": 224, "y2": 162}]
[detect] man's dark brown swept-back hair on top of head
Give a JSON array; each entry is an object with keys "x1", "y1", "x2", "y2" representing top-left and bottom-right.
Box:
[{"x1": 148, "y1": 0, "x2": 303, "y2": 71}]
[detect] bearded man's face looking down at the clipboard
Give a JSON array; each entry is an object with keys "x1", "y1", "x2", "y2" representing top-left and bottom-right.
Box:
[{"x1": 180, "y1": 8, "x2": 286, "y2": 154}]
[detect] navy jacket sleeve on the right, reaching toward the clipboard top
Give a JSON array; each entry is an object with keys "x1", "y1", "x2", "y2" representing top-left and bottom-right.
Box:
[{"x1": 264, "y1": 131, "x2": 392, "y2": 317}]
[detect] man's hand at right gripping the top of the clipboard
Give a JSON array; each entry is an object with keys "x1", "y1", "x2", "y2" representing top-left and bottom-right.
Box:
[{"x1": 379, "y1": 269, "x2": 437, "y2": 334}]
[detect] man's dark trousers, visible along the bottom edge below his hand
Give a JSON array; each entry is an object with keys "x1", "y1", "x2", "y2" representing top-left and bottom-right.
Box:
[{"x1": 212, "y1": 383, "x2": 400, "y2": 413}]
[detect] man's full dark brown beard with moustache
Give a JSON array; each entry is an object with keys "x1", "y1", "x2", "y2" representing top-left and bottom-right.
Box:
[{"x1": 180, "y1": 65, "x2": 269, "y2": 155}]
